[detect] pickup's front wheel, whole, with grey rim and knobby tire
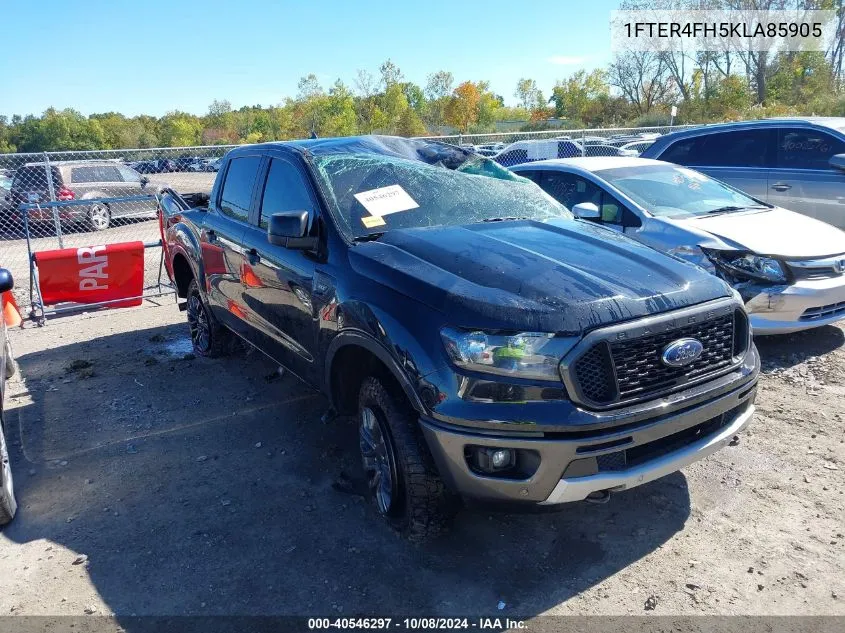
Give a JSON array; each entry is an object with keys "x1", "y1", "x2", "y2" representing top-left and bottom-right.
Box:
[{"x1": 358, "y1": 377, "x2": 458, "y2": 541}]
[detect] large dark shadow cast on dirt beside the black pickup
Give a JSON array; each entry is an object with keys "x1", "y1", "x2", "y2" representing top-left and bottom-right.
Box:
[{"x1": 4, "y1": 325, "x2": 690, "y2": 631}]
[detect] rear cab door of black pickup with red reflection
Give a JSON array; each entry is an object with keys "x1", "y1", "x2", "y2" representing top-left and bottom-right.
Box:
[{"x1": 198, "y1": 155, "x2": 262, "y2": 336}]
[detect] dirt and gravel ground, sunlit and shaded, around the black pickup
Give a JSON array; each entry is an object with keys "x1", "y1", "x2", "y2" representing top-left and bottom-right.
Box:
[{"x1": 0, "y1": 301, "x2": 845, "y2": 617}]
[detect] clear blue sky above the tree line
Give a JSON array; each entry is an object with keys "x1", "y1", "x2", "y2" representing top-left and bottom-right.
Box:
[{"x1": 0, "y1": 0, "x2": 619, "y2": 116}]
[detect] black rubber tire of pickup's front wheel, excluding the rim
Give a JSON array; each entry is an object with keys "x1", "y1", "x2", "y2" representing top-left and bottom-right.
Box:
[{"x1": 358, "y1": 376, "x2": 459, "y2": 542}]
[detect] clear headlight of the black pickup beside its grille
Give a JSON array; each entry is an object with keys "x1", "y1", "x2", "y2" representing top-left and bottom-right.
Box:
[{"x1": 440, "y1": 328, "x2": 578, "y2": 380}]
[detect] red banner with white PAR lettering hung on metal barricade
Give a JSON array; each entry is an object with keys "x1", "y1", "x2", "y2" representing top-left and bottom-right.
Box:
[{"x1": 35, "y1": 242, "x2": 144, "y2": 308}]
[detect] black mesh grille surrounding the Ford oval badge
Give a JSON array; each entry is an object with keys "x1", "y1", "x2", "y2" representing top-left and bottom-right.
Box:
[{"x1": 571, "y1": 310, "x2": 748, "y2": 406}]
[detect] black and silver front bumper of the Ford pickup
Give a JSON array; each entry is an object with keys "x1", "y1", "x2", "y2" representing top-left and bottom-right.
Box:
[{"x1": 421, "y1": 346, "x2": 759, "y2": 506}]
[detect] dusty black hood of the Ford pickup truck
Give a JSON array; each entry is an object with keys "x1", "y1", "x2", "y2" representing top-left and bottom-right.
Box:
[{"x1": 350, "y1": 220, "x2": 730, "y2": 334}]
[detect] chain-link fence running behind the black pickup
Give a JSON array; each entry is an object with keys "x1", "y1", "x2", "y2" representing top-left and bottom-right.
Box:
[{"x1": 0, "y1": 126, "x2": 700, "y2": 314}]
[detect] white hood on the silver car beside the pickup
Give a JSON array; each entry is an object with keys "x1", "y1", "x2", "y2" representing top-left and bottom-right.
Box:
[{"x1": 672, "y1": 207, "x2": 845, "y2": 258}]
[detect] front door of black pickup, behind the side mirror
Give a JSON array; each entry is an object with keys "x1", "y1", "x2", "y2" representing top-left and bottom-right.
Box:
[{"x1": 241, "y1": 156, "x2": 319, "y2": 383}]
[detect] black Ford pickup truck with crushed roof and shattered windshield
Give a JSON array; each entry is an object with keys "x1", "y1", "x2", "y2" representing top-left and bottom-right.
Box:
[{"x1": 161, "y1": 136, "x2": 759, "y2": 539}]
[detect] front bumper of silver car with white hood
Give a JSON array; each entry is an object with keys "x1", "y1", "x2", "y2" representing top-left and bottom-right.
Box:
[{"x1": 745, "y1": 275, "x2": 845, "y2": 334}]
